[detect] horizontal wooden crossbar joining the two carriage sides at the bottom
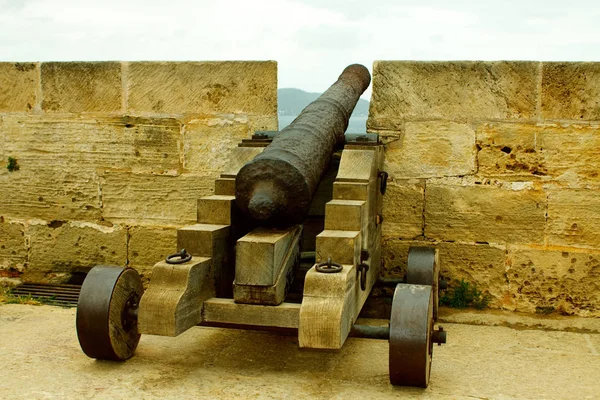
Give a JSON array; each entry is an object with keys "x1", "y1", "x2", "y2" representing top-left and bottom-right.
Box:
[{"x1": 202, "y1": 298, "x2": 300, "y2": 328}]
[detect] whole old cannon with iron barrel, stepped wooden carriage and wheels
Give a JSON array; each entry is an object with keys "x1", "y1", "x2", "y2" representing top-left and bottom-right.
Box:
[{"x1": 76, "y1": 65, "x2": 446, "y2": 387}]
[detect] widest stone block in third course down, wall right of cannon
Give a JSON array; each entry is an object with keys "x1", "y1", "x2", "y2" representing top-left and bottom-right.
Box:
[{"x1": 425, "y1": 183, "x2": 546, "y2": 243}]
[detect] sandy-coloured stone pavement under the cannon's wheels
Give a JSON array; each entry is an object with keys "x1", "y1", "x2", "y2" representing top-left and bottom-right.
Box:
[{"x1": 0, "y1": 304, "x2": 600, "y2": 399}]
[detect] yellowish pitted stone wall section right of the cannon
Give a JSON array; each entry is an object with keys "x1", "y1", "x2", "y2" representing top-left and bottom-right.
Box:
[{"x1": 367, "y1": 61, "x2": 600, "y2": 316}]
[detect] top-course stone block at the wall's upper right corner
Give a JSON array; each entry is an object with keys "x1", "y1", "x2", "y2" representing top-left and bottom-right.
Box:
[{"x1": 541, "y1": 62, "x2": 600, "y2": 120}]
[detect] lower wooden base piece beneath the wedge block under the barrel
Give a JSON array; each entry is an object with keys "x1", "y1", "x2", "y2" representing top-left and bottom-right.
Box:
[{"x1": 233, "y1": 226, "x2": 302, "y2": 305}]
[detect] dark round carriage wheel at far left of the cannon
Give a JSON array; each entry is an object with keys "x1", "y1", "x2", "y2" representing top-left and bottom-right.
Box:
[{"x1": 76, "y1": 265, "x2": 143, "y2": 361}]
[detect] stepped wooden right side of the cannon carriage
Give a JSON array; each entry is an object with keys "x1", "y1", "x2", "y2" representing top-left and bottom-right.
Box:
[{"x1": 298, "y1": 146, "x2": 383, "y2": 349}]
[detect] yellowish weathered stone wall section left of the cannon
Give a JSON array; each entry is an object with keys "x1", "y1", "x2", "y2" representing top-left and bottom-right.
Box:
[{"x1": 0, "y1": 62, "x2": 277, "y2": 282}]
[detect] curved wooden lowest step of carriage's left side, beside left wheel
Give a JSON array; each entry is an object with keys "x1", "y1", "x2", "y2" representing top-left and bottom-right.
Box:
[{"x1": 138, "y1": 257, "x2": 215, "y2": 336}]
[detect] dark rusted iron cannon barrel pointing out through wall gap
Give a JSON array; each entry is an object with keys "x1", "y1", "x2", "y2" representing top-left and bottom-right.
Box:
[{"x1": 235, "y1": 64, "x2": 371, "y2": 226}]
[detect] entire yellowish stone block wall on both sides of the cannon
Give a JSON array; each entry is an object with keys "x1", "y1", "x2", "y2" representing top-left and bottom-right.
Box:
[{"x1": 0, "y1": 61, "x2": 600, "y2": 316}]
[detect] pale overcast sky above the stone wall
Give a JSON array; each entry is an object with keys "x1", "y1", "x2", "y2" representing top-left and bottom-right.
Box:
[{"x1": 0, "y1": 0, "x2": 600, "y2": 97}]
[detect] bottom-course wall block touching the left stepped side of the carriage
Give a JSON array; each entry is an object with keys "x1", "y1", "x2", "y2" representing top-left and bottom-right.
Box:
[{"x1": 127, "y1": 226, "x2": 177, "y2": 277}]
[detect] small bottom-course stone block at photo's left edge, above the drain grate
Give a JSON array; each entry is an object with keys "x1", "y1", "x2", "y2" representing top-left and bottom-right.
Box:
[{"x1": 0, "y1": 222, "x2": 27, "y2": 276}]
